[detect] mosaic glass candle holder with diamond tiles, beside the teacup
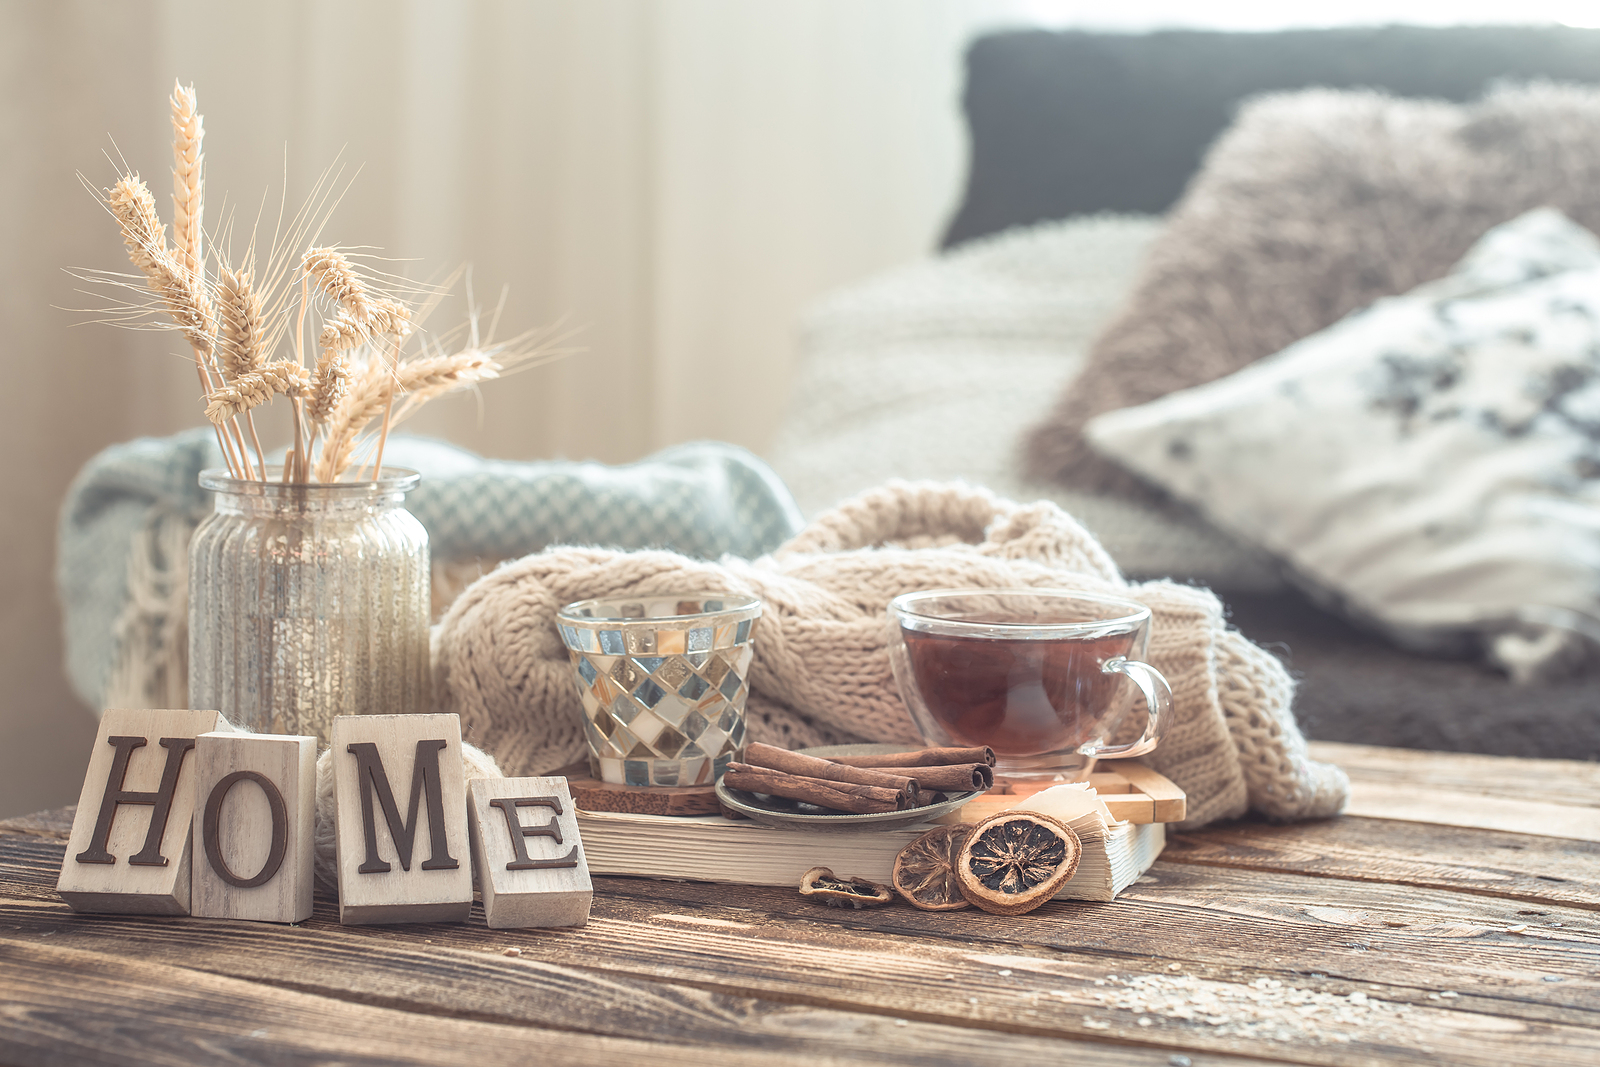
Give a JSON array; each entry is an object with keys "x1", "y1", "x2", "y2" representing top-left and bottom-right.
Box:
[{"x1": 557, "y1": 593, "x2": 762, "y2": 785}]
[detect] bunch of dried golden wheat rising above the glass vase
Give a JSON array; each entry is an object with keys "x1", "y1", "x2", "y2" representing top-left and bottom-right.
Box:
[{"x1": 93, "y1": 83, "x2": 555, "y2": 482}]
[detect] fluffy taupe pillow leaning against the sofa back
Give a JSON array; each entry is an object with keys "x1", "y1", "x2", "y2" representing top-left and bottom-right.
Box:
[{"x1": 1027, "y1": 85, "x2": 1600, "y2": 498}]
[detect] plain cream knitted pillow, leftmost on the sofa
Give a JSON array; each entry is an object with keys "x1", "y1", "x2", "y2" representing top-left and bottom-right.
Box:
[{"x1": 770, "y1": 216, "x2": 1278, "y2": 590}]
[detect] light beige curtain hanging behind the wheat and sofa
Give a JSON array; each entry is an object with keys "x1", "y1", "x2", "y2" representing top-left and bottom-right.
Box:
[{"x1": 0, "y1": 0, "x2": 1026, "y2": 816}]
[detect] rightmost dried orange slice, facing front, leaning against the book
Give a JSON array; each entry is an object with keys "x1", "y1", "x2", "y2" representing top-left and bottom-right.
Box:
[{"x1": 955, "y1": 809, "x2": 1083, "y2": 915}]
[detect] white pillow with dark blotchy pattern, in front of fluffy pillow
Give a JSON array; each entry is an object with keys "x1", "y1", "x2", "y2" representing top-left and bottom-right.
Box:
[{"x1": 1086, "y1": 210, "x2": 1600, "y2": 675}]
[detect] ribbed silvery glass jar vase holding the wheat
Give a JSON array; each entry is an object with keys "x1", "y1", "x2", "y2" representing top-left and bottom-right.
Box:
[{"x1": 189, "y1": 467, "x2": 430, "y2": 744}]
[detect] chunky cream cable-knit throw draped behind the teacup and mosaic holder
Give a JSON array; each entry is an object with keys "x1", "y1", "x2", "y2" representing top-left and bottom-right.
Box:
[{"x1": 434, "y1": 482, "x2": 1349, "y2": 827}]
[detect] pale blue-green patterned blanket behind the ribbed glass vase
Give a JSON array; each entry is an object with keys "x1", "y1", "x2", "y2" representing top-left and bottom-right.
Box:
[{"x1": 56, "y1": 430, "x2": 800, "y2": 709}]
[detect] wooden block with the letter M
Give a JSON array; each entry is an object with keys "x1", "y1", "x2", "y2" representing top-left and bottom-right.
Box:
[{"x1": 331, "y1": 715, "x2": 472, "y2": 923}]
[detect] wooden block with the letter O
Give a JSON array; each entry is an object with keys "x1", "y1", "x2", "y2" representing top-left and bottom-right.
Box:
[{"x1": 190, "y1": 733, "x2": 317, "y2": 923}]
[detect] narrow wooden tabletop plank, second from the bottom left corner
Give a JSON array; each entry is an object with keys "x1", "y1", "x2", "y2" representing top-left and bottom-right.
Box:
[{"x1": 0, "y1": 909, "x2": 1286, "y2": 1064}]
